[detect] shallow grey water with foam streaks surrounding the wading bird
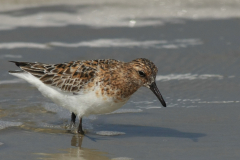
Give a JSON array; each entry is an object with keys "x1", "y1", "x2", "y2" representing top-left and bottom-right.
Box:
[{"x1": 0, "y1": 0, "x2": 240, "y2": 160}]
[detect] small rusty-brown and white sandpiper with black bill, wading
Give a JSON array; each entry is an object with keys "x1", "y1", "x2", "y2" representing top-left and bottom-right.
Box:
[{"x1": 9, "y1": 58, "x2": 166, "y2": 134}]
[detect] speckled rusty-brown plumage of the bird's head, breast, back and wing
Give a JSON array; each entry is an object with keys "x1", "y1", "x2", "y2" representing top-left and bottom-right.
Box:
[{"x1": 10, "y1": 58, "x2": 162, "y2": 101}]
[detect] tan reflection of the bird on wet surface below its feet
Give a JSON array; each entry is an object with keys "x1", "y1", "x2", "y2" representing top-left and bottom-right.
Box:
[{"x1": 38, "y1": 134, "x2": 109, "y2": 160}]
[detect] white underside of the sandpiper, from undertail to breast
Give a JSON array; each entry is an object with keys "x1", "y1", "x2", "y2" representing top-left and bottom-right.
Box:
[{"x1": 9, "y1": 73, "x2": 128, "y2": 117}]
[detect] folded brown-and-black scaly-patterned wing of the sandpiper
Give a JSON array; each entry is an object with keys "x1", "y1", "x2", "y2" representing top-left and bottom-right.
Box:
[{"x1": 9, "y1": 60, "x2": 99, "y2": 92}]
